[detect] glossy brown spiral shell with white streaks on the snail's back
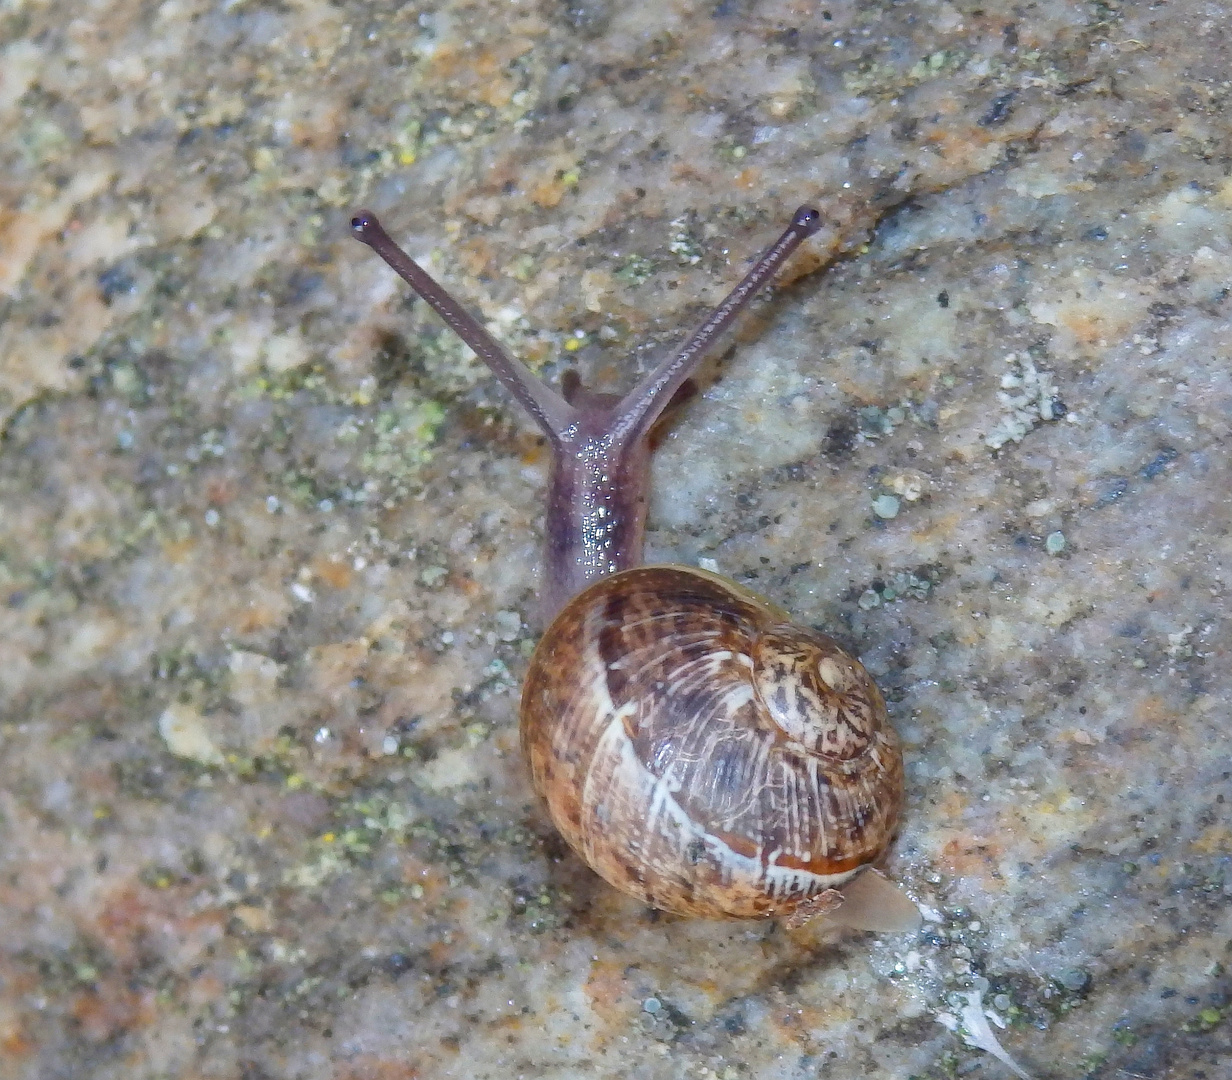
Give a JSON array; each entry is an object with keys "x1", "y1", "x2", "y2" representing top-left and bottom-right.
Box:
[{"x1": 521, "y1": 565, "x2": 903, "y2": 919}]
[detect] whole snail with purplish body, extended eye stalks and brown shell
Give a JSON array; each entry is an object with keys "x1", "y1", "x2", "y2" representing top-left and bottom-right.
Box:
[{"x1": 351, "y1": 207, "x2": 919, "y2": 930}]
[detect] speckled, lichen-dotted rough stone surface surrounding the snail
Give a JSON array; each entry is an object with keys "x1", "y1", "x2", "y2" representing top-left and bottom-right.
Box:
[{"x1": 0, "y1": 0, "x2": 1232, "y2": 1080}]
